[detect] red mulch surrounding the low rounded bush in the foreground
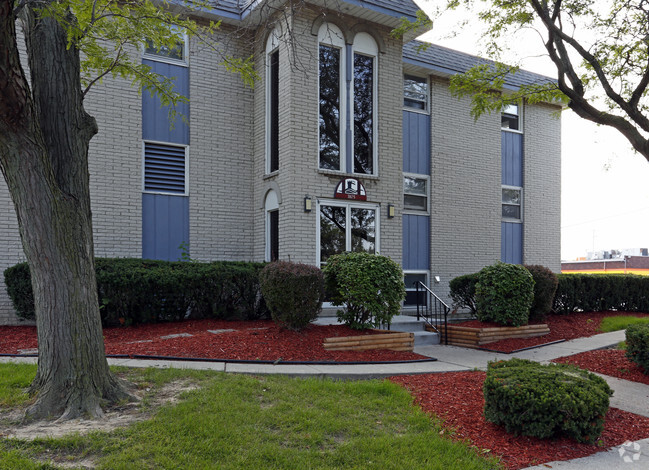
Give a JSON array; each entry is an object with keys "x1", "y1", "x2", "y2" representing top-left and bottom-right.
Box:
[{"x1": 390, "y1": 372, "x2": 649, "y2": 469}]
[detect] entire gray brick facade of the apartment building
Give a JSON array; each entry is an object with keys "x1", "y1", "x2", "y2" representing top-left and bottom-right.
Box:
[{"x1": 0, "y1": 4, "x2": 560, "y2": 324}]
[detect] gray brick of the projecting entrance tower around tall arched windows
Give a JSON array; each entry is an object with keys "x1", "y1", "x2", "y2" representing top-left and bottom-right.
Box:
[{"x1": 249, "y1": 8, "x2": 403, "y2": 264}]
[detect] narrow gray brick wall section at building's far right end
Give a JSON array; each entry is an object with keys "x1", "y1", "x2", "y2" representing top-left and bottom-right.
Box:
[{"x1": 523, "y1": 105, "x2": 561, "y2": 272}]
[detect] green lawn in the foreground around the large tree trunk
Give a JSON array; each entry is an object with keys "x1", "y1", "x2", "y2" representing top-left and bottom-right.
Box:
[{"x1": 0, "y1": 364, "x2": 500, "y2": 470}]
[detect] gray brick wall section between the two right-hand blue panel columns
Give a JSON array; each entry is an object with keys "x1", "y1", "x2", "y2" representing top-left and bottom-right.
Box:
[{"x1": 430, "y1": 78, "x2": 501, "y2": 299}]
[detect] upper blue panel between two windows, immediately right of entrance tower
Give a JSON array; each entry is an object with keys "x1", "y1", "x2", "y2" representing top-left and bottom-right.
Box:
[{"x1": 403, "y1": 111, "x2": 430, "y2": 175}]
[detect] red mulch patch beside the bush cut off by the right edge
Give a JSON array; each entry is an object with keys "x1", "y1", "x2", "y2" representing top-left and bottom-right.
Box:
[{"x1": 553, "y1": 349, "x2": 649, "y2": 385}]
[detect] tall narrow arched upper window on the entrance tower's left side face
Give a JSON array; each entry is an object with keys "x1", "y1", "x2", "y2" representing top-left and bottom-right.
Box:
[{"x1": 266, "y1": 30, "x2": 279, "y2": 173}]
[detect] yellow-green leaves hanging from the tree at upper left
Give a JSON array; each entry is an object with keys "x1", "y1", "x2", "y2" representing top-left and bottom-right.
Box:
[{"x1": 38, "y1": 0, "x2": 257, "y2": 106}]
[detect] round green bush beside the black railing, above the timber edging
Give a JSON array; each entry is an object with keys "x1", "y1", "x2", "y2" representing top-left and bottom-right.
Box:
[{"x1": 475, "y1": 262, "x2": 534, "y2": 326}]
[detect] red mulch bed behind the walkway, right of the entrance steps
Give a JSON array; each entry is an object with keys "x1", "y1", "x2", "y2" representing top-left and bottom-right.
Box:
[{"x1": 453, "y1": 312, "x2": 649, "y2": 353}]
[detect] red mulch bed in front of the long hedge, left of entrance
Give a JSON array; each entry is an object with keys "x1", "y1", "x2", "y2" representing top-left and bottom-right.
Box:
[{"x1": 0, "y1": 320, "x2": 427, "y2": 362}]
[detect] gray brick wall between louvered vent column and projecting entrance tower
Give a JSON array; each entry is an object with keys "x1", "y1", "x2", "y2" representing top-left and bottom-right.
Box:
[{"x1": 189, "y1": 26, "x2": 257, "y2": 261}]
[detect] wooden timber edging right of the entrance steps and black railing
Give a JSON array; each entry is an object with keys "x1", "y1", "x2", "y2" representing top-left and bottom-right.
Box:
[{"x1": 432, "y1": 323, "x2": 550, "y2": 348}]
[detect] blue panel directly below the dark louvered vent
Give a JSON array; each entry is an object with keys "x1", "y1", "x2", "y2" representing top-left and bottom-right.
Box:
[{"x1": 142, "y1": 194, "x2": 189, "y2": 261}]
